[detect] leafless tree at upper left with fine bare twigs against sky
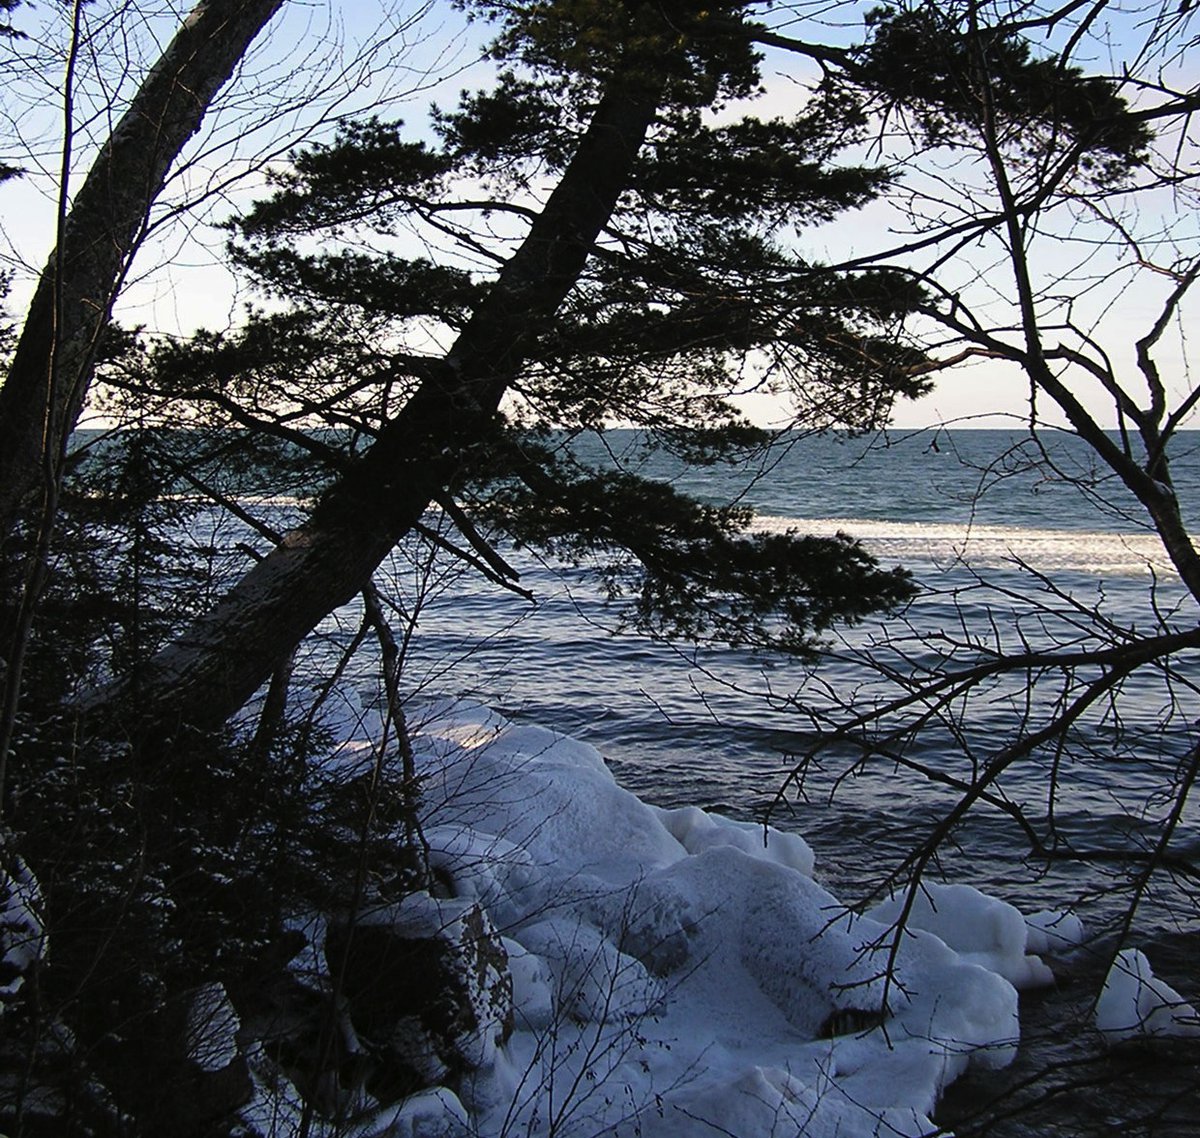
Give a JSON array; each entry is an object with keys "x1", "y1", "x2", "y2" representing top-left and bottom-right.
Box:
[{"x1": 0, "y1": 0, "x2": 452, "y2": 784}]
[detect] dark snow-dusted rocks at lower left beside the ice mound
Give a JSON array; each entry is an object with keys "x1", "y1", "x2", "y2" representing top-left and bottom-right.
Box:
[{"x1": 0, "y1": 845, "x2": 514, "y2": 1138}]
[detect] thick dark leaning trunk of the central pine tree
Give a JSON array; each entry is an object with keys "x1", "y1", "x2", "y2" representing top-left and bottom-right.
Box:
[{"x1": 85, "y1": 67, "x2": 661, "y2": 741}]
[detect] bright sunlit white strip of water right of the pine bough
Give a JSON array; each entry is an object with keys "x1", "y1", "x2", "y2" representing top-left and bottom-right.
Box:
[{"x1": 752, "y1": 515, "x2": 1175, "y2": 576}]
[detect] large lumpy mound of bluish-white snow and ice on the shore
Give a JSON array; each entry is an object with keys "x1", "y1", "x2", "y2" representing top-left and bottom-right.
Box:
[{"x1": 258, "y1": 702, "x2": 1108, "y2": 1138}]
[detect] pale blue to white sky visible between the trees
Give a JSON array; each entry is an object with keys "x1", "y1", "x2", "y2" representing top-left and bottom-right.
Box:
[{"x1": 0, "y1": 0, "x2": 1195, "y2": 427}]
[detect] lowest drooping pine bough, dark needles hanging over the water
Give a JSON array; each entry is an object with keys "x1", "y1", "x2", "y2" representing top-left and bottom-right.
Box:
[{"x1": 478, "y1": 439, "x2": 914, "y2": 657}]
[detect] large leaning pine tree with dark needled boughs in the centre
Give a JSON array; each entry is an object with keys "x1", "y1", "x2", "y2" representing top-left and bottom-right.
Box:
[{"x1": 91, "y1": 2, "x2": 924, "y2": 744}]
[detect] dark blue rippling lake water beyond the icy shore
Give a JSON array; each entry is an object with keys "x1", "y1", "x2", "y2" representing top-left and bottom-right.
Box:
[{"x1": 355, "y1": 431, "x2": 1200, "y2": 934}]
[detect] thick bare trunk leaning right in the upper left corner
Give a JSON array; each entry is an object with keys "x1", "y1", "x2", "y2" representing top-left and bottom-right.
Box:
[{"x1": 0, "y1": 0, "x2": 283, "y2": 545}]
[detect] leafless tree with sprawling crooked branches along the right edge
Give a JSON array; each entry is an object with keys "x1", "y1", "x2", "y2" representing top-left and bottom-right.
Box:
[{"x1": 790, "y1": 2, "x2": 1200, "y2": 979}]
